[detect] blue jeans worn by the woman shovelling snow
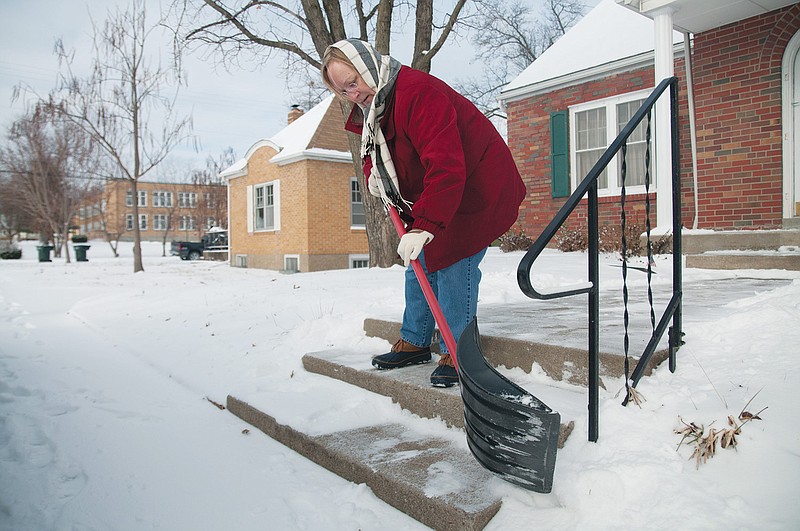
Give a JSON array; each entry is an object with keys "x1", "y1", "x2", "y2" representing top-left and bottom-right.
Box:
[{"x1": 400, "y1": 249, "x2": 486, "y2": 353}]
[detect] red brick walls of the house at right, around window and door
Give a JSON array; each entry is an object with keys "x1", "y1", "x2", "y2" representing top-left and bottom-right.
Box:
[{"x1": 507, "y1": 4, "x2": 800, "y2": 241}]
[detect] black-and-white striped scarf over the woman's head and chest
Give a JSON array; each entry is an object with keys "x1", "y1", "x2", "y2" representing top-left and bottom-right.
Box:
[{"x1": 331, "y1": 39, "x2": 410, "y2": 212}]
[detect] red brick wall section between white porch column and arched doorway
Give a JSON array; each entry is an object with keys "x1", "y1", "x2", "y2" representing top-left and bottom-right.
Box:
[{"x1": 693, "y1": 4, "x2": 800, "y2": 229}]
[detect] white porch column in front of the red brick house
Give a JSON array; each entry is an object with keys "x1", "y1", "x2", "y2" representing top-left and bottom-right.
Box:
[{"x1": 651, "y1": 7, "x2": 675, "y2": 231}]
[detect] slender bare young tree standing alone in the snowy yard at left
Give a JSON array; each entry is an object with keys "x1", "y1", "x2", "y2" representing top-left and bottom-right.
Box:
[{"x1": 49, "y1": 0, "x2": 191, "y2": 272}]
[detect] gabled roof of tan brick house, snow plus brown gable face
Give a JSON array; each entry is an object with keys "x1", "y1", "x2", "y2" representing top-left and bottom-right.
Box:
[{"x1": 220, "y1": 95, "x2": 353, "y2": 179}]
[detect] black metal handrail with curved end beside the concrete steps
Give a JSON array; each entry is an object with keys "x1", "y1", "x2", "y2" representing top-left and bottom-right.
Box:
[{"x1": 517, "y1": 77, "x2": 683, "y2": 441}]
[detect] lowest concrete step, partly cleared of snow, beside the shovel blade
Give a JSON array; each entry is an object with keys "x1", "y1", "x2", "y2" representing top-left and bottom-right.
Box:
[{"x1": 227, "y1": 396, "x2": 501, "y2": 531}]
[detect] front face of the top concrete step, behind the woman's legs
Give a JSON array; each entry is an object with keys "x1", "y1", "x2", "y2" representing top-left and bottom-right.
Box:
[{"x1": 364, "y1": 319, "x2": 669, "y2": 387}]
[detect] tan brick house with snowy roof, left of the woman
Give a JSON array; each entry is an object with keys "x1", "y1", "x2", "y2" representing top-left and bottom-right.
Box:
[{"x1": 220, "y1": 96, "x2": 369, "y2": 272}]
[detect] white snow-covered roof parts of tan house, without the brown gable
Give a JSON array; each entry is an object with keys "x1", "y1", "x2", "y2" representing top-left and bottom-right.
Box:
[{"x1": 220, "y1": 95, "x2": 352, "y2": 179}]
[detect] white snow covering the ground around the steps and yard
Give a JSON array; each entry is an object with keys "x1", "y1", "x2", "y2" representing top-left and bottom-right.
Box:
[{"x1": 0, "y1": 242, "x2": 800, "y2": 531}]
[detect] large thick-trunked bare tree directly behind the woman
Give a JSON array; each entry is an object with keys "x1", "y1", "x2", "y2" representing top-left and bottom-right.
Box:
[{"x1": 172, "y1": 0, "x2": 467, "y2": 267}]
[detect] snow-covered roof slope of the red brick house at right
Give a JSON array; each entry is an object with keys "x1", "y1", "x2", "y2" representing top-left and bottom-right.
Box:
[{"x1": 500, "y1": 0, "x2": 683, "y2": 101}]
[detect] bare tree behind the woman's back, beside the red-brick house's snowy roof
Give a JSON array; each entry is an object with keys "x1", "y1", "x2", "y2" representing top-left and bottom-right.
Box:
[{"x1": 456, "y1": 0, "x2": 586, "y2": 116}]
